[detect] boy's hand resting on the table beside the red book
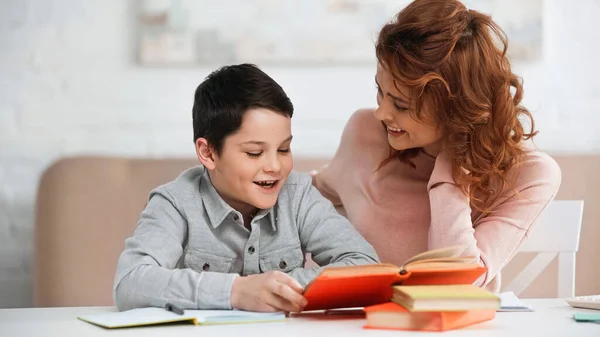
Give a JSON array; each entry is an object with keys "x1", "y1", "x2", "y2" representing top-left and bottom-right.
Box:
[{"x1": 231, "y1": 271, "x2": 306, "y2": 312}]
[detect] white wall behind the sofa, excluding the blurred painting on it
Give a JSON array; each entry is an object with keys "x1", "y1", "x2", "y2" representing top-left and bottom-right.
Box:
[{"x1": 0, "y1": 0, "x2": 600, "y2": 307}]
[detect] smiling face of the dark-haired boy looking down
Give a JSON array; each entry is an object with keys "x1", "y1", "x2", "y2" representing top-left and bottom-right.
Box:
[{"x1": 196, "y1": 108, "x2": 293, "y2": 215}]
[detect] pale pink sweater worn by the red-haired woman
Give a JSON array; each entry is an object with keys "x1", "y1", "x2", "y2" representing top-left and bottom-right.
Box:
[{"x1": 314, "y1": 110, "x2": 561, "y2": 292}]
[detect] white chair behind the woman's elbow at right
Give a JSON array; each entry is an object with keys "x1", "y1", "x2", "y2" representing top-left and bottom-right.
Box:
[{"x1": 505, "y1": 200, "x2": 583, "y2": 298}]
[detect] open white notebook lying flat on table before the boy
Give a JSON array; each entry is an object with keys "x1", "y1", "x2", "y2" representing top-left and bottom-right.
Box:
[{"x1": 77, "y1": 308, "x2": 285, "y2": 329}]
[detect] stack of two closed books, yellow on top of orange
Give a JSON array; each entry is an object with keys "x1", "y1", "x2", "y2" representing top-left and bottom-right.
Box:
[{"x1": 364, "y1": 284, "x2": 500, "y2": 331}]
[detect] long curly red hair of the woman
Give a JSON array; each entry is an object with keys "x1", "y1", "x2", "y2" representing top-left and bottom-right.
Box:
[{"x1": 376, "y1": 0, "x2": 537, "y2": 211}]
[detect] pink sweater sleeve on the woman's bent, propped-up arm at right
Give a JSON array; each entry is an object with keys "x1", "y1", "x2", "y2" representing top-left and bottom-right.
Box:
[{"x1": 427, "y1": 152, "x2": 561, "y2": 286}]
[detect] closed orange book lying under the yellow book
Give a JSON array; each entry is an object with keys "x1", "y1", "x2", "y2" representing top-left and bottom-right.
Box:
[{"x1": 364, "y1": 302, "x2": 496, "y2": 331}]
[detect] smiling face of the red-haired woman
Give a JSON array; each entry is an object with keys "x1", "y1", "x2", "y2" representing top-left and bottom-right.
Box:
[{"x1": 374, "y1": 65, "x2": 443, "y2": 156}]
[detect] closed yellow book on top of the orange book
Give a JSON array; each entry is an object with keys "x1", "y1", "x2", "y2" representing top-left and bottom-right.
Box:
[{"x1": 392, "y1": 284, "x2": 500, "y2": 311}]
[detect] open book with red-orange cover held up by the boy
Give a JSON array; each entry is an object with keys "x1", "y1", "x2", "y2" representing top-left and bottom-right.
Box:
[{"x1": 304, "y1": 246, "x2": 487, "y2": 310}]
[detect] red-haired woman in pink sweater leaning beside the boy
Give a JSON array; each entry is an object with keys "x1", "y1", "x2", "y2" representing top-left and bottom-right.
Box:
[{"x1": 313, "y1": 0, "x2": 561, "y2": 291}]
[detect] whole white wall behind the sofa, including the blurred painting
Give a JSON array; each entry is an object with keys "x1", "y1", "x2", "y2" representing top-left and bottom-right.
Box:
[{"x1": 0, "y1": 0, "x2": 600, "y2": 307}]
